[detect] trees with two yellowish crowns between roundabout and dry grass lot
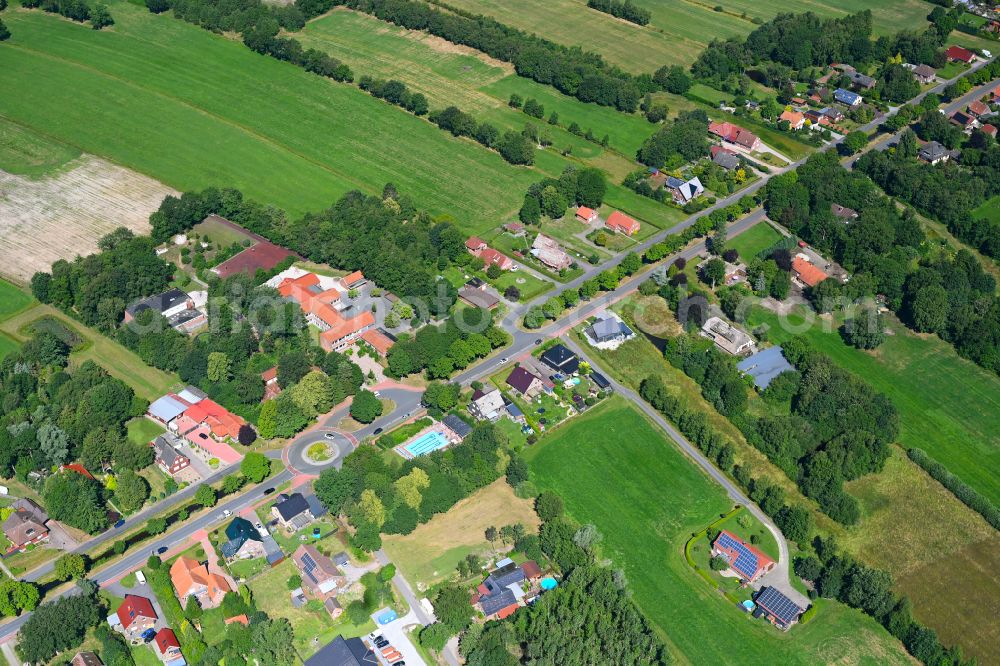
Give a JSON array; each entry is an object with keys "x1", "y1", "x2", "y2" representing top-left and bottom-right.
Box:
[{"x1": 315, "y1": 424, "x2": 509, "y2": 551}]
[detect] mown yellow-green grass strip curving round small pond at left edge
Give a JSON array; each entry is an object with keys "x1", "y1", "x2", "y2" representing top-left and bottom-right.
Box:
[{"x1": 0, "y1": 304, "x2": 179, "y2": 401}]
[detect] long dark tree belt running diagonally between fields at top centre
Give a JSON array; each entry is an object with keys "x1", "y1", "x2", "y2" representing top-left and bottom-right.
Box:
[{"x1": 304, "y1": 0, "x2": 655, "y2": 112}]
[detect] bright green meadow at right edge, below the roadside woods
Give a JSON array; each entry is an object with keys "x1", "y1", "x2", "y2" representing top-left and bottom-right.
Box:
[{"x1": 749, "y1": 308, "x2": 1000, "y2": 502}]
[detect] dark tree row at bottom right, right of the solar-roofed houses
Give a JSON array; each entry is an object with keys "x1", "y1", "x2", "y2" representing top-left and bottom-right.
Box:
[{"x1": 795, "y1": 537, "x2": 974, "y2": 666}]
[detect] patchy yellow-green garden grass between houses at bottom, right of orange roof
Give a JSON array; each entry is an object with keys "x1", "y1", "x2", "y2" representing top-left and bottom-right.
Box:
[{"x1": 250, "y1": 559, "x2": 375, "y2": 660}]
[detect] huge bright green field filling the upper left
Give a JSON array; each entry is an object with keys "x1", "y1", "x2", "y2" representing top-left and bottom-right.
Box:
[{"x1": 0, "y1": 2, "x2": 544, "y2": 232}]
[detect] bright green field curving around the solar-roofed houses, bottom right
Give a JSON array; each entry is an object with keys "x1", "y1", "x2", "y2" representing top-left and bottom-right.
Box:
[{"x1": 526, "y1": 398, "x2": 908, "y2": 664}]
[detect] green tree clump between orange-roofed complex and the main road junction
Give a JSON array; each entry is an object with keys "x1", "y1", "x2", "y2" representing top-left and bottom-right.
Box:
[{"x1": 388, "y1": 308, "x2": 510, "y2": 379}]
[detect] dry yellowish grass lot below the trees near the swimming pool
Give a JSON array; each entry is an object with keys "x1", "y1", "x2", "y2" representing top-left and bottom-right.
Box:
[{"x1": 382, "y1": 479, "x2": 538, "y2": 592}]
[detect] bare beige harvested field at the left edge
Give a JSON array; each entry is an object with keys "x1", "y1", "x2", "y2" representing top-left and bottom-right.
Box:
[{"x1": 0, "y1": 155, "x2": 172, "y2": 282}]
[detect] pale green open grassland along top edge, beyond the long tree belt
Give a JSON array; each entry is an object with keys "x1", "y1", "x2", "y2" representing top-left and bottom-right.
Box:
[{"x1": 444, "y1": 0, "x2": 928, "y2": 74}]
